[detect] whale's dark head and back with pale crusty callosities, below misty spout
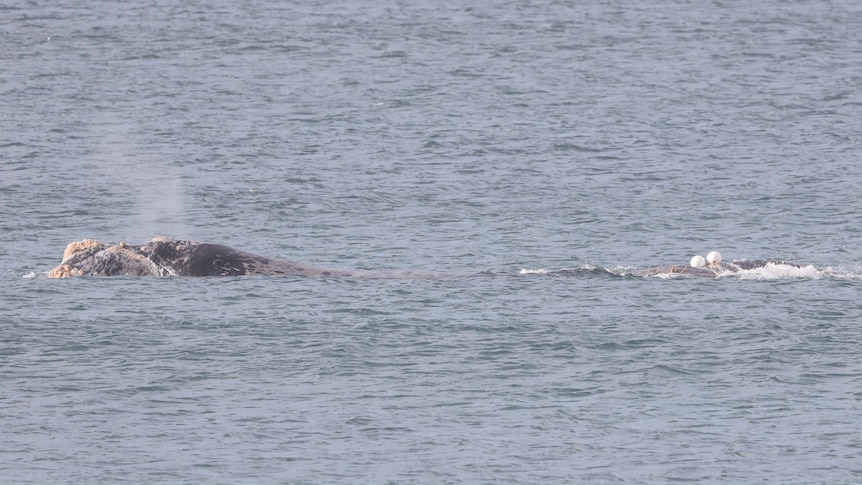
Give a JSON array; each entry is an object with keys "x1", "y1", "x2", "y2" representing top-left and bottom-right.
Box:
[{"x1": 48, "y1": 236, "x2": 358, "y2": 278}]
